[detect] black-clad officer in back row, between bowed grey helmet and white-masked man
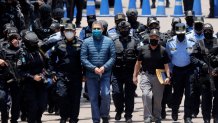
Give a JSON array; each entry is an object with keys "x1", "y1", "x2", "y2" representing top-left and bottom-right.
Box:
[{"x1": 32, "y1": 4, "x2": 54, "y2": 40}]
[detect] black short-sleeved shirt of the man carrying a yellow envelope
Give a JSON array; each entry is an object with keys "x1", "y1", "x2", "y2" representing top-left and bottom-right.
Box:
[{"x1": 138, "y1": 44, "x2": 170, "y2": 74}]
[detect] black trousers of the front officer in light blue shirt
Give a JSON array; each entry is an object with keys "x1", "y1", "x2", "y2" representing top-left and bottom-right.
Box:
[{"x1": 172, "y1": 65, "x2": 195, "y2": 118}]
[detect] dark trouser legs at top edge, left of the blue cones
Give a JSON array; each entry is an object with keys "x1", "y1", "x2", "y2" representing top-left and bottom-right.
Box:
[{"x1": 66, "y1": 0, "x2": 84, "y2": 24}]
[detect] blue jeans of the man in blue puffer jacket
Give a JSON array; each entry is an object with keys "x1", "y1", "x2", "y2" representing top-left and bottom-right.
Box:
[{"x1": 87, "y1": 76, "x2": 111, "y2": 123}]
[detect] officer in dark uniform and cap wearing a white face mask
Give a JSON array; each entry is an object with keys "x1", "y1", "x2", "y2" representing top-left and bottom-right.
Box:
[{"x1": 50, "y1": 23, "x2": 82, "y2": 123}]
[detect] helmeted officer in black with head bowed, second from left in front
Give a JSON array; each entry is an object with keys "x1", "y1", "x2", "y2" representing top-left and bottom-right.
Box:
[{"x1": 20, "y1": 31, "x2": 48, "y2": 123}]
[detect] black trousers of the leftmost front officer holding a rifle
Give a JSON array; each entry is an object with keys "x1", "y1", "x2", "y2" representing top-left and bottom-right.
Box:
[{"x1": 9, "y1": 82, "x2": 21, "y2": 123}]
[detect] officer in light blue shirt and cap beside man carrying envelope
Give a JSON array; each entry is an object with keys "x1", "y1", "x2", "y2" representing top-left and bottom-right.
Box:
[{"x1": 166, "y1": 23, "x2": 195, "y2": 123}]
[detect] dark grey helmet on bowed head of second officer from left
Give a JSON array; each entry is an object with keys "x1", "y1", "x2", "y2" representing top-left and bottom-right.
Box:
[{"x1": 23, "y1": 31, "x2": 39, "y2": 44}]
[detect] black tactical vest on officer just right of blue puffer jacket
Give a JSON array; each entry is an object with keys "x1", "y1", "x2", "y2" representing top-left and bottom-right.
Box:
[{"x1": 114, "y1": 36, "x2": 137, "y2": 68}]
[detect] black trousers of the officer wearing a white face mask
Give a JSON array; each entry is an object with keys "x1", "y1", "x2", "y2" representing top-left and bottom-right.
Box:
[{"x1": 57, "y1": 76, "x2": 82, "y2": 122}]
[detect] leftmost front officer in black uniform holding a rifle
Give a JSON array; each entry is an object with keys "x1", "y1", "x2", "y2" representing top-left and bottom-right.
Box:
[{"x1": 1, "y1": 27, "x2": 22, "y2": 123}]
